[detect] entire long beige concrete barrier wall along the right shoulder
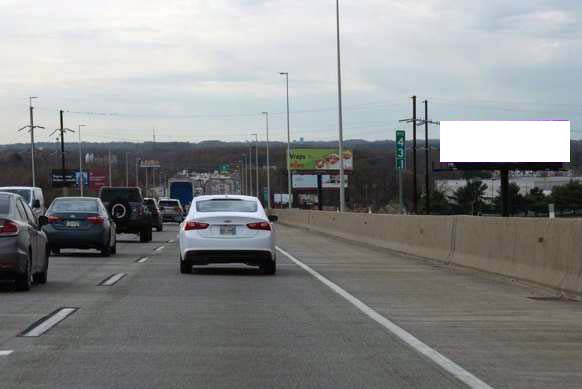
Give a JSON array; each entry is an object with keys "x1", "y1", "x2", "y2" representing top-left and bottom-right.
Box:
[{"x1": 272, "y1": 210, "x2": 582, "y2": 294}]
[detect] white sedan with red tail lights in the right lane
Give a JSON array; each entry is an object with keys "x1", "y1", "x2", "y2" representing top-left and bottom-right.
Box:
[{"x1": 178, "y1": 195, "x2": 277, "y2": 274}]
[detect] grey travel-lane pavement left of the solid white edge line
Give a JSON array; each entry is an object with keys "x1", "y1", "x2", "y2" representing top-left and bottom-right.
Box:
[{"x1": 0, "y1": 225, "x2": 470, "y2": 388}]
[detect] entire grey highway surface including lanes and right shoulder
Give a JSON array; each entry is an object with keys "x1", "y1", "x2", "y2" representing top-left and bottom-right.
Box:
[{"x1": 0, "y1": 225, "x2": 582, "y2": 388}]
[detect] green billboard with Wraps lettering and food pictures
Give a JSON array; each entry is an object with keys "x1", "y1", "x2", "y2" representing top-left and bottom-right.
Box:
[{"x1": 289, "y1": 149, "x2": 354, "y2": 170}]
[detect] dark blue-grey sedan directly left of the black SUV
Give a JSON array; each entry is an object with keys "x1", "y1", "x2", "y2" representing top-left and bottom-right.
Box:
[{"x1": 43, "y1": 197, "x2": 117, "y2": 256}]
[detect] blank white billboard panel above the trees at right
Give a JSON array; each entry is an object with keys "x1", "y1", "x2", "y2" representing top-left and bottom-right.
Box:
[{"x1": 440, "y1": 120, "x2": 570, "y2": 163}]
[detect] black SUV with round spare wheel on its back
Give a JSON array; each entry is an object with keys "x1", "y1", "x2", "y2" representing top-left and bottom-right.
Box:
[{"x1": 99, "y1": 186, "x2": 152, "y2": 242}]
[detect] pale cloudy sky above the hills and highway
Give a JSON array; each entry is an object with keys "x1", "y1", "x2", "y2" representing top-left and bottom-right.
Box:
[{"x1": 0, "y1": 0, "x2": 582, "y2": 143}]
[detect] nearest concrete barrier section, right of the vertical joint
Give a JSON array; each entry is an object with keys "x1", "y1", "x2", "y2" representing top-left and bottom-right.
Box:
[{"x1": 451, "y1": 216, "x2": 582, "y2": 294}]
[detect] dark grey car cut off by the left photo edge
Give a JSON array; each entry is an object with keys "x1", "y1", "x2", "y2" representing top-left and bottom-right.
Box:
[{"x1": 0, "y1": 192, "x2": 49, "y2": 291}]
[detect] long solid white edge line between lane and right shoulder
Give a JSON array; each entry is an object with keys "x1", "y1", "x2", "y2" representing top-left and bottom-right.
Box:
[{"x1": 277, "y1": 246, "x2": 492, "y2": 389}]
